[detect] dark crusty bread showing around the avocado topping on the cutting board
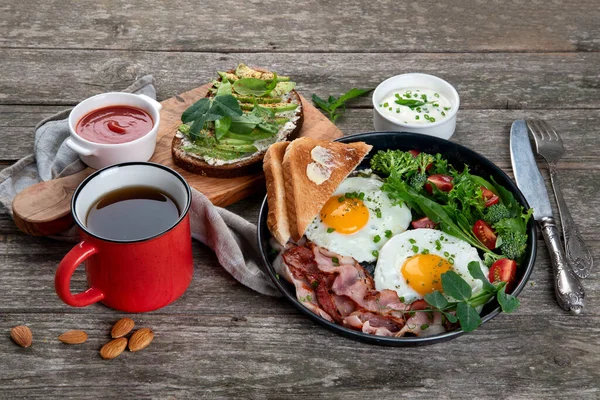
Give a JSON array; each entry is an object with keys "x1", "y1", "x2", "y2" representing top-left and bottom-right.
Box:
[{"x1": 171, "y1": 68, "x2": 304, "y2": 178}]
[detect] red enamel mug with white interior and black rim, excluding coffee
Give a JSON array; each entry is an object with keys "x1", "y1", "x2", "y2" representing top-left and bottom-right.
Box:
[{"x1": 54, "y1": 162, "x2": 194, "y2": 312}]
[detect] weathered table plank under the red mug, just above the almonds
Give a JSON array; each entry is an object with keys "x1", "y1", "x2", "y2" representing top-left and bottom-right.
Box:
[{"x1": 0, "y1": 203, "x2": 600, "y2": 320}]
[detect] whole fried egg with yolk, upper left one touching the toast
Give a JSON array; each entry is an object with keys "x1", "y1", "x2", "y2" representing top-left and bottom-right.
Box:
[{"x1": 306, "y1": 177, "x2": 411, "y2": 262}]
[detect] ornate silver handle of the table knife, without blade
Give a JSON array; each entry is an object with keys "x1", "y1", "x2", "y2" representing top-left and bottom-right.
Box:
[{"x1": 539, "y1": 218, "x2": 585, "y2": 314}]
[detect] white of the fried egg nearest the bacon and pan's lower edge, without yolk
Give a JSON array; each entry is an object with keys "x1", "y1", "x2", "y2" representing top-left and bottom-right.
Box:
[{"x1": 374, "y1": 229, "x2": 489, "y2": 303}]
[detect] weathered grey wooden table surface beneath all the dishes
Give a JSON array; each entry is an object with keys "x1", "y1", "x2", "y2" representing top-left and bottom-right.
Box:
[{"x1": 0, "y1": 0, "x2": 600, "y2": 399}]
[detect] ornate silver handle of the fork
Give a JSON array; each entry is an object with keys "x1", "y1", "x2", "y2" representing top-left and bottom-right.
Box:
[{"x1": 550, "y1": 166, "x2": 594, "y2": 278}]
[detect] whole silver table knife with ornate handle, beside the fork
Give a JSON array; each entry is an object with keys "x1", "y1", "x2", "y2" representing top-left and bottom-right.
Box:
[{"x1": 510, "y1": 120, "x2": 585, "y2": 314}]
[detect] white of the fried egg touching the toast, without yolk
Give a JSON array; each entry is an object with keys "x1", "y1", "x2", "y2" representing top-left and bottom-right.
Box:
[{"x1": 306, "y1": 177, "x2": 412, "y2": 262}]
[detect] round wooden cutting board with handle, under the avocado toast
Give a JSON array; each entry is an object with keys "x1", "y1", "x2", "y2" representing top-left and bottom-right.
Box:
[{"x1": 12, "y1": 84, "x2": 342, "y2": 236}]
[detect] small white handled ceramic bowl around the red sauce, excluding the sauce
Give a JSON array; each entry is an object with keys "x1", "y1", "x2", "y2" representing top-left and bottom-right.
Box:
[{"x1": 67, "y1": 92, "x2": 162, "y2": 169}]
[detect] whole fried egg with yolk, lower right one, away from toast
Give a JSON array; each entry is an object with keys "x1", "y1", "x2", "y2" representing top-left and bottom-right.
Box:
[{"x1": 375, "y1": 229, "x2": 488, "y2": 303}]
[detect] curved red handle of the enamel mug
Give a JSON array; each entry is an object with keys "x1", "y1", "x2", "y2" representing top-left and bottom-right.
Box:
[{"x1": 54, "y1": 241, "x2": 104, "y2": 307}]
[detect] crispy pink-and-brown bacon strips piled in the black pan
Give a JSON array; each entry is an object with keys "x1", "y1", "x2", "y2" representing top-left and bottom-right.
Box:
[{"x1": 281, "y1": 243, "x2": 443, "y2": 336}]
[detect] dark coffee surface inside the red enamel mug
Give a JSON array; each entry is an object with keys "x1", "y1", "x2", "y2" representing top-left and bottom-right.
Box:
[{"x1": 86, "y1": 186, "x2": 180, "y2": 240}]
